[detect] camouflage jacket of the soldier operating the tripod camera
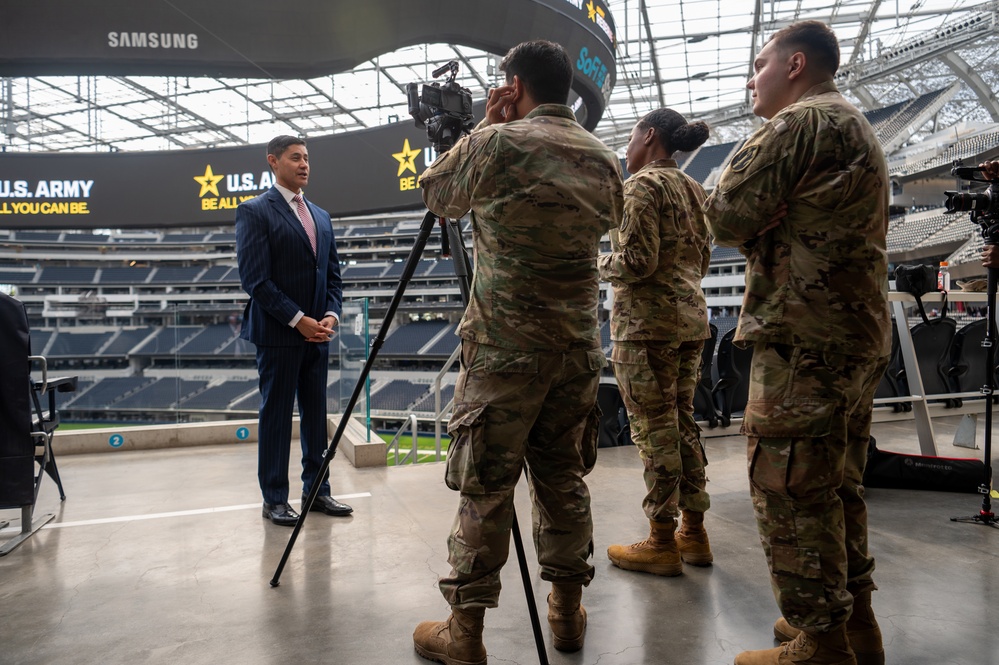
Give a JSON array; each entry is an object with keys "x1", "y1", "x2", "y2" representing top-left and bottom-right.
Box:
[{"x1": 420, "y1": 104, "x2": 623, "y2": 351}]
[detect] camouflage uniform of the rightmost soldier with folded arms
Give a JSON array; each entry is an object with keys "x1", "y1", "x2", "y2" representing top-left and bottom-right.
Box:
[{"x1": 705, "y1": 81, "x2": 891, "y2": 632}]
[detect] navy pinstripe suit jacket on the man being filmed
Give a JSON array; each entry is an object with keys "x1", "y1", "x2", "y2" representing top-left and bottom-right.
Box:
[{"x1": 236, "y1": 187, "x2": 343, "y2": 346}]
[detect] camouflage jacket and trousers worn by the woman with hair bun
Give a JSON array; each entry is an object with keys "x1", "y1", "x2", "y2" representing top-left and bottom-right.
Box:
[{"x1": 597, "y1": 159, "x2": 711, "y2": 522}]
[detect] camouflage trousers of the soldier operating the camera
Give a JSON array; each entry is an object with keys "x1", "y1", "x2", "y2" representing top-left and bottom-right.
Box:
[{"x1": 440, "y1": 340, "x2": 606, "y2": 608}]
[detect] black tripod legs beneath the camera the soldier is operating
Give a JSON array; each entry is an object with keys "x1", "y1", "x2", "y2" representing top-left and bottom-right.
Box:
[{"x1": 270, "y1": 210, "x2": 548, "y2": 665}]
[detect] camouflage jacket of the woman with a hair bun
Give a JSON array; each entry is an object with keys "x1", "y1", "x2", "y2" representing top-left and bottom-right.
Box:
[{"x1": 597, "y1": 159, "x2": 711, "y2": 342}]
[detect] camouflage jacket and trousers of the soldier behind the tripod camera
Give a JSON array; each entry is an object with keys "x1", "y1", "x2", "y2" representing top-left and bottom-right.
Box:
[{"x1": 420, "y1": 104, "x2": 622, "y2": 608}]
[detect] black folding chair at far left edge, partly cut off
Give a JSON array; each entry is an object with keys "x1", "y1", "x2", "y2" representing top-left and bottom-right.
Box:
[{"x1": 0, "y1": 293, "x2": 76, "y2": 556}]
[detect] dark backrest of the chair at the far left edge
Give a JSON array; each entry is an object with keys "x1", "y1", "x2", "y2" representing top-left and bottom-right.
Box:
[{"x1": 0, "y1": 293, "x2": 35, "y2": 507}]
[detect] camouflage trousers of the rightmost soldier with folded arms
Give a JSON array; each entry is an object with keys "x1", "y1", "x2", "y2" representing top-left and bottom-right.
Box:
[{"x1": 742, "y1": 343, "x2": 888, "y2": 632}]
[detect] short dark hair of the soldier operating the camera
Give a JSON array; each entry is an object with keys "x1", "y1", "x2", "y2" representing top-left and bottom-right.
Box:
[{"x1": 500, "y1": 39, "x2": 572, "y2": 104}]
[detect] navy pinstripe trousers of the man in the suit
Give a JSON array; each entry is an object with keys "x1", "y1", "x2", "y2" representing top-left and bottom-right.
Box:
[{"x1": 257, "y1": 340, "x2": 330, "y2": 503}]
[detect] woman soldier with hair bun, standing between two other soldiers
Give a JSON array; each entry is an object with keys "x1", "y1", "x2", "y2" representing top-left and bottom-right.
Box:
[{"x1": 598, "y1": 108, "x2": 712, "y2": 576}]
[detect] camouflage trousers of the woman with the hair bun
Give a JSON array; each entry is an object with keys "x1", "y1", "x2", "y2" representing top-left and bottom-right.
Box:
[{"x1": 611, "y1": 340, "x2": 711, "y2": 522}]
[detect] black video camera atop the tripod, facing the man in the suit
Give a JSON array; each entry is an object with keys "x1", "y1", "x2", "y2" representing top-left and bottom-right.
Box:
[{"x1": 406, "y1": 60, "x2": 475, "y2": 152}]
